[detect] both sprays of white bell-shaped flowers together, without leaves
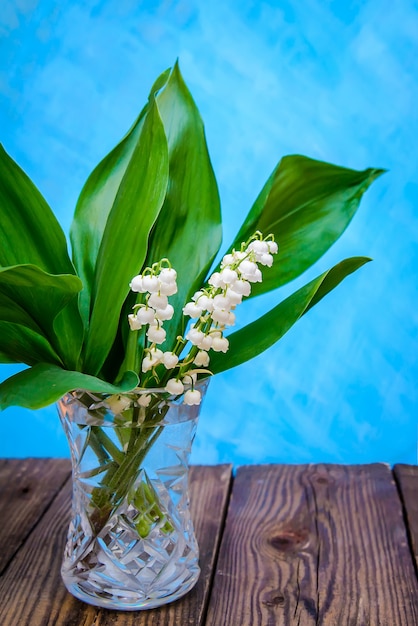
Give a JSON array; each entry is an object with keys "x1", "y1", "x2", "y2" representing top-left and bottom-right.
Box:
[{"x1": 128, "y1": 232, "x2": 278, "y2": 406}]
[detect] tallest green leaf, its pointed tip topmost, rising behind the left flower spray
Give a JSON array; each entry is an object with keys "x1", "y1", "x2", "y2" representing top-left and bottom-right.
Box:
[{"x1": 142, "y1": 64, "x2": 222, "y2": 346}]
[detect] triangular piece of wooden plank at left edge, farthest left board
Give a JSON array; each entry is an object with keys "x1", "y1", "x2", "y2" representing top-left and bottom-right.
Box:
[{"x1": 0, "y1": 459, "x2": 71, "y2": 573}]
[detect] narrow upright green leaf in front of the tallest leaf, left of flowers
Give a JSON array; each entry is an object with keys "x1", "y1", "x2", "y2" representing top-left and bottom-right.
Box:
[{"x1": 84, "y1": 102, "x2": 168, "y2": 375}]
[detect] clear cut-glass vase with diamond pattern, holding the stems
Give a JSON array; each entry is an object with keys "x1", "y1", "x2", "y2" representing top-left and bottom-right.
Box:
[{"x1": 58, "y1": 381, "x2": 207, "y2": 610}]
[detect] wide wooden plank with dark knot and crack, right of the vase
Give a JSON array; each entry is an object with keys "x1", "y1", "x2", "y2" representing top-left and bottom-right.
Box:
[{"x1": 206, "y1": 464, "x2": 418, "y2": 626}]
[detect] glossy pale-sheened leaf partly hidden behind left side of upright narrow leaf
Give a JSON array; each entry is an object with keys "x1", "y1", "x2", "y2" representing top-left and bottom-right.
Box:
[{"x1": 70, "y1": 70, "x2": 169, "y2": 325}]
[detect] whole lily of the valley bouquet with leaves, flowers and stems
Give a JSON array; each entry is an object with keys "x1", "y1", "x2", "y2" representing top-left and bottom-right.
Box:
[{"x1": 0, "y1": 65, "x2": 381, "y2": 605}]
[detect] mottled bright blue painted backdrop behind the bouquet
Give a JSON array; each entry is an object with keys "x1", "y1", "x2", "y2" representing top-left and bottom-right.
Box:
[{"x1": 0, "y1": 0, "x2": 418, "y2": 464}]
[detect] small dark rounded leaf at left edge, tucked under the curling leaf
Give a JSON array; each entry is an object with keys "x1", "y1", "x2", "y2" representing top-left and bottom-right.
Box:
[{"x1": 0, "y1": 320, "x2": 61, "y2": 365}]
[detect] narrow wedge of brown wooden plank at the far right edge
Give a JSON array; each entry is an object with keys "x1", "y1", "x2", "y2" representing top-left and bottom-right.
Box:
[{"x1": 393, "y1": 464, "x2": 418, "y2": 567}]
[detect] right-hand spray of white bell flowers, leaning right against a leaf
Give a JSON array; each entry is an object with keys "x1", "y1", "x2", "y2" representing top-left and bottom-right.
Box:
[{"x1": 183, "y1": 233, "x2": 278, "y2": 367}]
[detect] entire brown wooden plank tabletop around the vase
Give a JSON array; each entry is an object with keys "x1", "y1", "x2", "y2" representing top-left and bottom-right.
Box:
[{"x1": 0, "y1": 459, "x2": 418, "y2": 626}]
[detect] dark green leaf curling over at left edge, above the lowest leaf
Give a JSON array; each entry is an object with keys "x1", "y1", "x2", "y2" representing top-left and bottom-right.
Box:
[{"x1": 0, "y1": 265, "x2": 83, "y2": 365}]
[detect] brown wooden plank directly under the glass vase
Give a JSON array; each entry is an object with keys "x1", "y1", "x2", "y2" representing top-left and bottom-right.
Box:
[{"x1": 0, "y1": 458, "x2": 231, "y2": 626}]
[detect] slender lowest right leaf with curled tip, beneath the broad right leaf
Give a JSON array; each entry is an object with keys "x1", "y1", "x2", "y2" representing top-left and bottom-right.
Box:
[{"x1": 210, "y1": 257, "x2": 371, "y2": 374}]
